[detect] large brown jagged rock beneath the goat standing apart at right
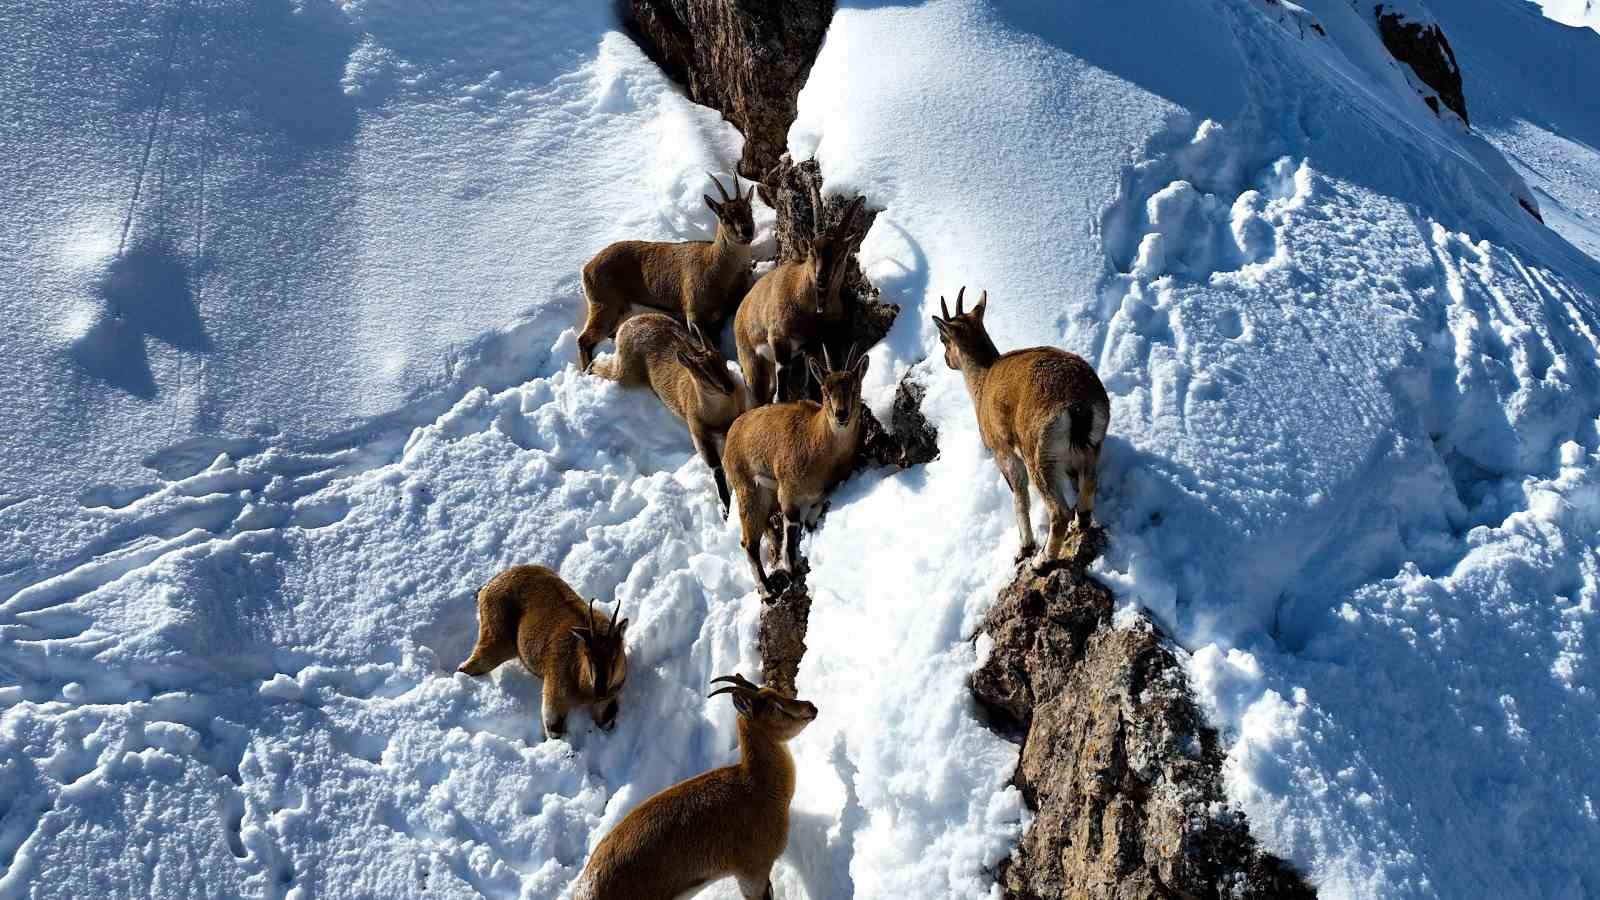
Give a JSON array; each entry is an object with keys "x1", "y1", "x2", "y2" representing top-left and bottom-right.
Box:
[{"x1": 973, "y1": 565, "x2": 1315, "y2": 900}]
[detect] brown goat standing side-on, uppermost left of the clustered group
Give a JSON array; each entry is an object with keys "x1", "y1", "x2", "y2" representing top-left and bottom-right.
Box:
[{"x1": 578, "y1": 175, "x2": 755, "y2": 372}]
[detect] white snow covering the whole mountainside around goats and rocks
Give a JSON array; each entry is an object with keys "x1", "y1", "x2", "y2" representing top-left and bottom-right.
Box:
[{"x1": 0, "y1": 0, "x2": 1600, "y2": 900}]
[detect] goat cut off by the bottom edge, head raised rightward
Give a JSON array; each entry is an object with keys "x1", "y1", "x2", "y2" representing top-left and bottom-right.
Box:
[{"x1": 574, "y1": 674, "x2": 816, "y2": 900}]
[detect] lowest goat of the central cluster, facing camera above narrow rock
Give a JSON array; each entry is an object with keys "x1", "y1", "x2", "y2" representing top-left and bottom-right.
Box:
[{"x1": 722, "y1": 348, "x2": 867, "y2": 596}]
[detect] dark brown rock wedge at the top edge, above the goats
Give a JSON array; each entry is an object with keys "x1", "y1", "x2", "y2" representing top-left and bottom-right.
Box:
[{"x1": 622, "y1": 0, "x2": 834, "y2": 179}]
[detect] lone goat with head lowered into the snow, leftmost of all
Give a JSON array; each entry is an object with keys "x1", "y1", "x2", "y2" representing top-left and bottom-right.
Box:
[{"x1": 456, "y1": 565, "x2": 627, "y2": 738}]
